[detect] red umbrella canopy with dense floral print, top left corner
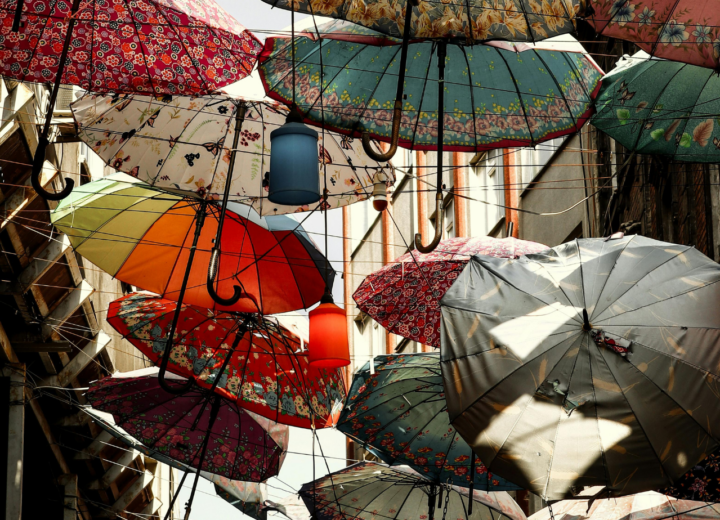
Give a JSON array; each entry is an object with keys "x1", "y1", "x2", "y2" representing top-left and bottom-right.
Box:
[{"x1": 0, "y1": 0, "x2": 262, "y2": 94}]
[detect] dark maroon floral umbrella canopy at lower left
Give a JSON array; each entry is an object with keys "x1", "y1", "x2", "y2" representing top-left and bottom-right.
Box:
[{"x1": 87, "y1": 369, "x2": 288, "y2": 482}]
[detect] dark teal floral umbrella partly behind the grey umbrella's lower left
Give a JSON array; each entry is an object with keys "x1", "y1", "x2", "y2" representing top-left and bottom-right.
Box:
[{"x1": 337, "y1": 353, "x2": 519, "y2": 491}]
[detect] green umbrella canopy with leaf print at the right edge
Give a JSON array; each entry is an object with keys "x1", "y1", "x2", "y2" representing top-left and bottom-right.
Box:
[{"x1": 592, "y1": 53, "x2": 720, "y2": 163}]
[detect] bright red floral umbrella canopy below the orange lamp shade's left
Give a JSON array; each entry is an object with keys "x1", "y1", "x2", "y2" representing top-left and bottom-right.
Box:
[{"x1": 107, "y1": 293, "x2": 345, "y2": 428}]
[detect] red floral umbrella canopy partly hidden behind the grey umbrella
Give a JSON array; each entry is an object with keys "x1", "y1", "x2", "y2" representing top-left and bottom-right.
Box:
[{"x1": 353, "y1": 237, "x2": 548, "y2": 347}]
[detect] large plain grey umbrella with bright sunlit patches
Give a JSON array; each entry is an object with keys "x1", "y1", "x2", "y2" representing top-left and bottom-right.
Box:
[{"x1": 440, "y1": 236, "x2": 720, "y2": 501}]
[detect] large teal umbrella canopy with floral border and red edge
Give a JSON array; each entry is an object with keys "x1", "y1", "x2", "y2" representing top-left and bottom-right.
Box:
[{"x1": 259, "y1": 22, "x2": 602, "y2": 151}]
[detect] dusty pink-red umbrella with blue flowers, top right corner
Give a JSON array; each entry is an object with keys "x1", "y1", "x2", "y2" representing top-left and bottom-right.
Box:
[{"x1": 585, "y1": 0, "x2": 720, "y2": 69}]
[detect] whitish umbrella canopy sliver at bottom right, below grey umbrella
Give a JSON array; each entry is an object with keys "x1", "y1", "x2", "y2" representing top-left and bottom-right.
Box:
[{"x1": 530, "y1": 488, "x2": 720, "y2": 520}]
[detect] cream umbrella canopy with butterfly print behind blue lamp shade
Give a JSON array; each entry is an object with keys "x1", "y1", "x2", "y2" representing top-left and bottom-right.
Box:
[{"x1": 72, "y1": 94, "x2": 394, "y2": 215}]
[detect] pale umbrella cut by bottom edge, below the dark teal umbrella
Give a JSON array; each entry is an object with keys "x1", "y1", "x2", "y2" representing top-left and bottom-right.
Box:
[{"x1": 300, "y1": 462, "x2": 525, "y2": 520}]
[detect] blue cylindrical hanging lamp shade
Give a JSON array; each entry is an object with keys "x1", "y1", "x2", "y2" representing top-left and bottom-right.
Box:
[{"x1": 268, "y1": 122, "x2": 320, "y2": 206}]
